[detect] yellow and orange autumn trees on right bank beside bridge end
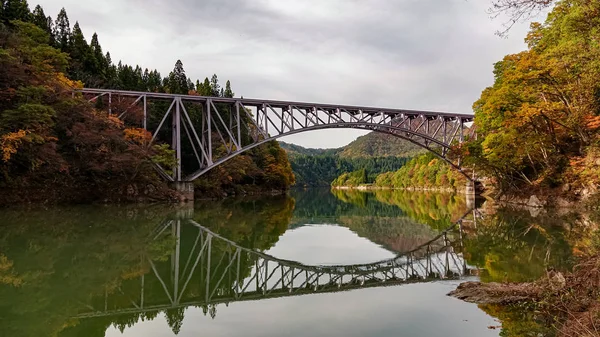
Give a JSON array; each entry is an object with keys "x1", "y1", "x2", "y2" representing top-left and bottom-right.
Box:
[{"x1": 462, "y1": 0, "x2": 600, "y2": 190}]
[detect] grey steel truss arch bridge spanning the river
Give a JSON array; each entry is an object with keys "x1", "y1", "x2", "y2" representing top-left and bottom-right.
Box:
[{"x1": 77, "y1": 89, "x2": 475, "y2": 182}]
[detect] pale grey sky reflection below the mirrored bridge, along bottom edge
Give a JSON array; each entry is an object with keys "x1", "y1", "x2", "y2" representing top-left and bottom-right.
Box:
[{"x1": 106, "y1": 281, "x2": 499, "y2": 337}]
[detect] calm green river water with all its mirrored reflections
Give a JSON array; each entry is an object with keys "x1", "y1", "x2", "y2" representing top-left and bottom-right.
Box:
[{"x1": 0, "y1": 190, "x2": 593, "y2": 337}]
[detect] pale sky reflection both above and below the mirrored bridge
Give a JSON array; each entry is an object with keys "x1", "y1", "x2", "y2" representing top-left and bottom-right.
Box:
[{"x1": 106, "y1": 226, "x2": 499, "y2": 337}]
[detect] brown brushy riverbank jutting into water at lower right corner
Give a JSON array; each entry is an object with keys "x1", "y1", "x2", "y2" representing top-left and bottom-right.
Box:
[{"x1": 448, "y1": 255, "x2": 600, "y2": 337}]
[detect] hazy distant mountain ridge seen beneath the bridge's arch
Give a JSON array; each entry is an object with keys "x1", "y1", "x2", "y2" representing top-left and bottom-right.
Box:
[{"x1": 279, "y1": 132, "x2": 423, "y2": 158}]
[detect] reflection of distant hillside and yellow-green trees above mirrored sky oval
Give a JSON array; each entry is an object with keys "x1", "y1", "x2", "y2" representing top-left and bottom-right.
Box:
[{"x1": 292, "y1": 189, "x2": 466, "y2": 252}]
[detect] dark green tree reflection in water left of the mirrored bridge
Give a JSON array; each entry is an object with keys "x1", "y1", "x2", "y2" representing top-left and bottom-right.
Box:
[{"x1": 0, "y1": 207, "x2": 172, "y2": 336}]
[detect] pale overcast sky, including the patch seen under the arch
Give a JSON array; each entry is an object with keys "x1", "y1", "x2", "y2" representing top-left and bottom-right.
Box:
[{"x1": 36, "y1": 0, "x2": 527, "y2": 147}]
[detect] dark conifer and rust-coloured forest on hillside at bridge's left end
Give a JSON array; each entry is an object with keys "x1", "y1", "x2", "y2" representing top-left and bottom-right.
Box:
[{"x1": 0, "y1": 0, "x2": 294, "y2": 204}]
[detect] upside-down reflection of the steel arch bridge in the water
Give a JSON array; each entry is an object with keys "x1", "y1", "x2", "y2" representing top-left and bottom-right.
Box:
[{"x1": 76, "y1": 213, "x2": 469, "y2": 319}]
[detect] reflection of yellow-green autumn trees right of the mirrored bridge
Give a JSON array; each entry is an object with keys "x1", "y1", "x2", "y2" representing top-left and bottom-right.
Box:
[{"x1": 465, "y1": 209, "x2": 575, "y2": 282}]
